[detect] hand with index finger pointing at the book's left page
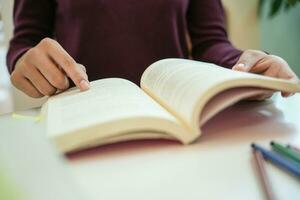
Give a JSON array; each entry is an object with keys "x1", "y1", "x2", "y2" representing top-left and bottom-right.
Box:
[{"x1": 11, "y1": 38, "x2": 89, "y2": 98}]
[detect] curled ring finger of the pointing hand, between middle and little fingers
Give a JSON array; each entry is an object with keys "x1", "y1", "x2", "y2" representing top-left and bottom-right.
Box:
[{"x1": 23, "y1": 63, "x2": 57, "y2": 96}]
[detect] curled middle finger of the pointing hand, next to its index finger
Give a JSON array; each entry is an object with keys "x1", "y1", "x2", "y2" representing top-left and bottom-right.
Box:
[{"x1": 31, "y1": 54, "x2": 69, "y2": 90}]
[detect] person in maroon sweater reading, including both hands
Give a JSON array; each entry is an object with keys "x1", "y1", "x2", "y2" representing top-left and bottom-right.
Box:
[{"x1": 7, "y1": 0, "x2": 298, "y2": 98}]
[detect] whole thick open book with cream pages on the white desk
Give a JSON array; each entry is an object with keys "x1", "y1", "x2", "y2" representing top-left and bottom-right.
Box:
[{"x1": 42, "y1": 59, "x2": 300, "y2": 153}]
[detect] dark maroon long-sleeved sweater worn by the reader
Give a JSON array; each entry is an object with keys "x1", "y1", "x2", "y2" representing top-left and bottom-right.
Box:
[{"x1": 7, "y1": 0, "x2": 241, "y2": 83}]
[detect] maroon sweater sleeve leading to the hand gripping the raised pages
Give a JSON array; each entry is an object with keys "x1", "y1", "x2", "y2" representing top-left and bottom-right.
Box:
[{"x1": 187, "y1": 0, "x2": 242, "y2": 68}]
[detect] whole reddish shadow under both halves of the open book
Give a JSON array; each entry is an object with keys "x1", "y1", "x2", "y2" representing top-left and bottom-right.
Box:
[{"x1": 67, "y1": 100, "x2": 295, "y2": 162}]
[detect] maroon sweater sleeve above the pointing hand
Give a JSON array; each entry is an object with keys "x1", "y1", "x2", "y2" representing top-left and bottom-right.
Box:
[{"x1": 7, "y1": 0, "x2": 55, "y2": 73}]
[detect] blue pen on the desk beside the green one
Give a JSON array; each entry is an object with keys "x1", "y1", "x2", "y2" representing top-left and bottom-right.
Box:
[{"x1": 251, "y1": 144, "x2": 300, "y2": 178}]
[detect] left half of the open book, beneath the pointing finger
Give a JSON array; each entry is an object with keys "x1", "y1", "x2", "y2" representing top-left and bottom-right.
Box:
[{"x1": 45, "y1": 78, "x2": 190, "y2": 151}]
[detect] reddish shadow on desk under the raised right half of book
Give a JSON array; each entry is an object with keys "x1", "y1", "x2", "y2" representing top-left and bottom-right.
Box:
[{"x1": 198, "y1": 100, "x2": 296, "y2": 143}]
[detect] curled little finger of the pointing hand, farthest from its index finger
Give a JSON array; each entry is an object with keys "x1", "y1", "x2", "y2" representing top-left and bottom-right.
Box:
[{"x1": 11, "y1": 73, "x2": 44, "y2": 98}]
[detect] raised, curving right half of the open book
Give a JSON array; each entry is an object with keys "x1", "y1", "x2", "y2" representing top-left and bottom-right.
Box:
[{"x1": 141, "y1": 59, "x2": 300, "y2": 136}]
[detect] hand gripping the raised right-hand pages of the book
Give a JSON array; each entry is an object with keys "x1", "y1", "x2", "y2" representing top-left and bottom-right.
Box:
[{"x1": 232, "y1": 50, "x2": 299, "y2": 100}]
